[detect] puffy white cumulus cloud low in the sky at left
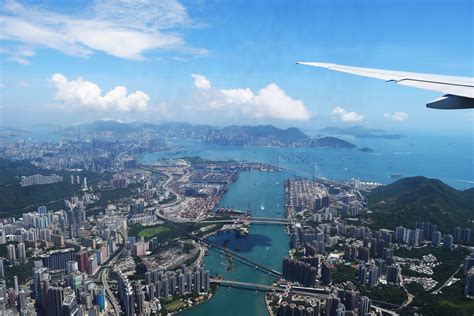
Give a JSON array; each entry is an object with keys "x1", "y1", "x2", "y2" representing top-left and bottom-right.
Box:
[{"x1": 49, "y1": 73, "x2": 150, "y2": 112}]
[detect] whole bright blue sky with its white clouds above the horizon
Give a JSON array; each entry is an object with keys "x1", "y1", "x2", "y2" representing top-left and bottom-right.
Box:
[{"x1": 0, "y1": 0, "x2": 474, "y2": 133}]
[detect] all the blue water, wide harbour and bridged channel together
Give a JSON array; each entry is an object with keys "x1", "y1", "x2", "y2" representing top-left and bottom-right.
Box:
[{"x1": 138, "y1": 137, "x2": 473, "y2": 315}]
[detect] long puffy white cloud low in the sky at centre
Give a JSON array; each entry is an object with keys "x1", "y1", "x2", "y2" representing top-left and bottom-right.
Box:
[{"x1": 191, "y1": 74, "x2": 312, "y2": 120}]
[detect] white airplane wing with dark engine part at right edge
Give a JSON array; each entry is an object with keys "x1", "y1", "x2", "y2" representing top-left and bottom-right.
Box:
[{"x1": 297, "y1": 62, "x2": 474, "y2": 109}]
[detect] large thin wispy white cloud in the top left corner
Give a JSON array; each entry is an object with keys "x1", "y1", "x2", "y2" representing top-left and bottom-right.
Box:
[{"x1": 0, "y1": 0, "x2": 206, "y2": 64}]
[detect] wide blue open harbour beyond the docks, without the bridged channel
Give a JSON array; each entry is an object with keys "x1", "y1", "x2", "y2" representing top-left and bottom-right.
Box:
[{"x1": 140, "y1": 134, "x2": 474, "y2": 190}]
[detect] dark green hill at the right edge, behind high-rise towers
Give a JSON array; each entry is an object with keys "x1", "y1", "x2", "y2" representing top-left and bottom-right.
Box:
[{"x1": 368, "y1": 177, "x2": 474, "y2": 233}]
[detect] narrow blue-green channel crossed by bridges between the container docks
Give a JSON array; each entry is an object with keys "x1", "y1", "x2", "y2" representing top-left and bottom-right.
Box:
[{"x1": 180, "y1": 172, "x2": 288, "y2": 316}]
